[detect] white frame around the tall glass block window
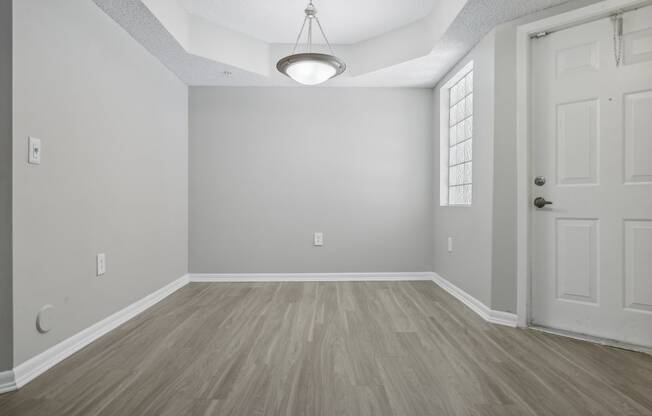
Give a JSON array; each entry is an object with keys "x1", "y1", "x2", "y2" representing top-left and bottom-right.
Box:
[{"x1": 439, "y1": 61, "x2": 476, "y2": 208}]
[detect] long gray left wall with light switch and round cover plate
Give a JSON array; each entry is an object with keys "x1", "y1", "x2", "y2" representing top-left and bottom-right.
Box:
[{"x1": 13, "y1": 0, "x2": 188, "y2": 365}]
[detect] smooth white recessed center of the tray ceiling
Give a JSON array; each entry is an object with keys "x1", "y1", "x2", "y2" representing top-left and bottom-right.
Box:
[{"x1": 178, "y1": 0, "x2": 436, "y2": 44}]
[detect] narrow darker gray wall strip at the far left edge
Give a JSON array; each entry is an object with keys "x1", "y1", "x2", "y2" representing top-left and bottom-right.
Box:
[{"x1": 0, "y1": 0, "x2": 13, "y2": 372}]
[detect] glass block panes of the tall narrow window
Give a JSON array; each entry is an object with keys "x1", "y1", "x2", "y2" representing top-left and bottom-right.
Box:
[{"x1": 448, "y1": 68, "x2": 473, "y2": 205}]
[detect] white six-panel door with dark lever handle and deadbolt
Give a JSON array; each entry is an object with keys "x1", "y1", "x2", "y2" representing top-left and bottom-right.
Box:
[{"x1": 530, "y1": 6, "x2": 652, "y2": 347}]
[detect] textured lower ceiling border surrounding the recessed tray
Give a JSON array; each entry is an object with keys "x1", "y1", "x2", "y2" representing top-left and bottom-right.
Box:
[{"x1": 94, "y1": 0, "x2": 584, "y2": 87}]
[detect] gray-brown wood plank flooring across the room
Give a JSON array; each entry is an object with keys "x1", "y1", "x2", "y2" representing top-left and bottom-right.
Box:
[{"x1": 0, "y1": 282, "x2": 652, "y2": 416}]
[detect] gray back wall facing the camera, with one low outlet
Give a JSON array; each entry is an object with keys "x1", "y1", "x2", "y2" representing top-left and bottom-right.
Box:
[{"x1": 190, "y1": 87, "x2": 433, "y2": 273}]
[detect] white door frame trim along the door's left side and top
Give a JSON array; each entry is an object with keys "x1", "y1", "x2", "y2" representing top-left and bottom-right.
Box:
[{"x1": 516, "y1": 0, "x2": 650, "y2": 327}]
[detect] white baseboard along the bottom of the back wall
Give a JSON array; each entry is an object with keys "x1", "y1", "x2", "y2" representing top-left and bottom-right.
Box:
[{"x1": 189, "y1": 272, "x2": 433, "y2": 283}]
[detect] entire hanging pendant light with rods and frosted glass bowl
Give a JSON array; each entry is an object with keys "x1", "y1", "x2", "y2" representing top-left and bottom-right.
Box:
[{"x1": 276, "y1": 0, "x2": 346, "y2": 85}]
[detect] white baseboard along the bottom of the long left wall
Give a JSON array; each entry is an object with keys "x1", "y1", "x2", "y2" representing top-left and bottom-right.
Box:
[{"x1": 10, "y1": 275, "x2": 189, "y2": 392}]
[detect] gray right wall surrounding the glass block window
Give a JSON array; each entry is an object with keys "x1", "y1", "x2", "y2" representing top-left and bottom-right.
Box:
[{"x1": 433, "y1": 31, "x2": 494, "y2": 305}]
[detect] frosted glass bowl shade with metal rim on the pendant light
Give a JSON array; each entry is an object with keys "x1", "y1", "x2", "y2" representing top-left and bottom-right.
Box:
[{"x1": 276, "y1": 53, "x2": 346, "y2": 85}]
